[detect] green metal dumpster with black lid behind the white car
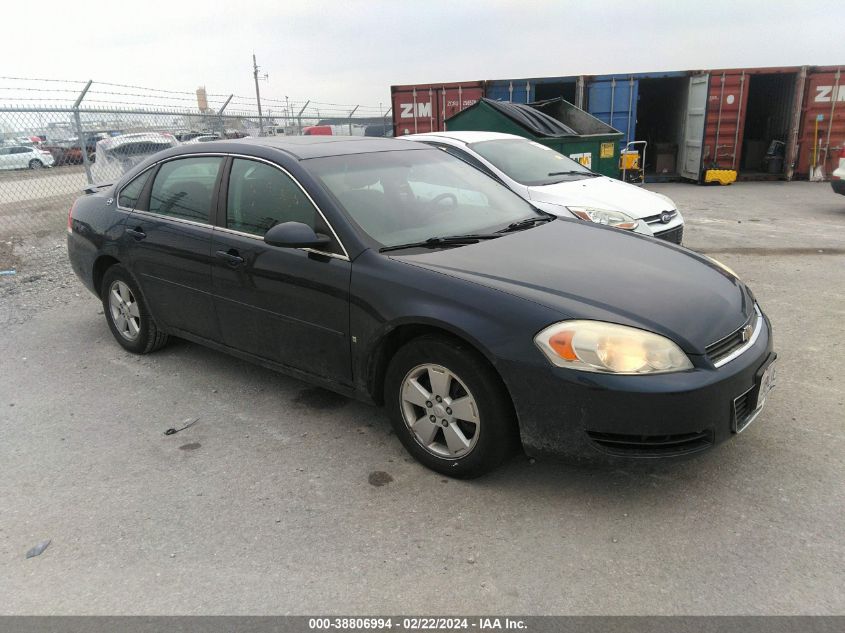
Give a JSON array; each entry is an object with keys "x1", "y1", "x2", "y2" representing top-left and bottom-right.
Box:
[{"x1": 446, "y1": 98, "x2": 622, "y2": 178}]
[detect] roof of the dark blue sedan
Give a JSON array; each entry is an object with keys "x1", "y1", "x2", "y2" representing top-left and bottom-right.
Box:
[{"x1": 211, "y1": 136, "x2": 425, "y2": 159}]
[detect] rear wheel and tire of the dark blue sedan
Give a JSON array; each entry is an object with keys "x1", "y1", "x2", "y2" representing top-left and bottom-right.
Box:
[{"x1": 100, "y1": 264, "x2": 167, "y2": 354}]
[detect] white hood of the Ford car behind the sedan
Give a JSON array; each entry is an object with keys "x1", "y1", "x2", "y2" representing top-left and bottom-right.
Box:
[{"x1": 528, "y1": 176, "x2": 671, "y2": 220}]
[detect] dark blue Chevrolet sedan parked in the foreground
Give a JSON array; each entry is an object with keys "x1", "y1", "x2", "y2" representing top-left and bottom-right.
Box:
[{"x1": 68, "y1": 137, "x2": 775, "y2": 477}]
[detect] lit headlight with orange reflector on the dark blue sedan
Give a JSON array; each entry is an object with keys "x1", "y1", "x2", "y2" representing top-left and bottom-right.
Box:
[{"x1": 534, "y1": 321, "x2": 692, "y2": 374}]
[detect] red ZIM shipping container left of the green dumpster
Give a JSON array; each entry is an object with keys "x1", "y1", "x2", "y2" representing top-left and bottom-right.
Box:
[{"x1": 390, "y1": 81, "x2": 484, "y2": 136}]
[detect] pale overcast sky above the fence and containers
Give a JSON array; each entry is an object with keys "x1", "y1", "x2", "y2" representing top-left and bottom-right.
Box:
[{"x1": 0, "y1": 0, "x2": 845, "y2": 106}]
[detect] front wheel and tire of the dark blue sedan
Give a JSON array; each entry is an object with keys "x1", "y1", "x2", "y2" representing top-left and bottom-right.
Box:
[{"x1": 385, "y1": 336, "x2": 517, "y2": 479}]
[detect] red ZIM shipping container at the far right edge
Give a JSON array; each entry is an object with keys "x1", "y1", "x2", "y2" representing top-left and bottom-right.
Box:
[{"x1": 796, "y1": 66, "x2": 845, "y2": 178}]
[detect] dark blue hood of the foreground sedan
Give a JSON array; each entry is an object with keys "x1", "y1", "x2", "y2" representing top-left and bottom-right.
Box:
[{"x1": 391, "y1": 219, "x2": 754, "y2": 354}]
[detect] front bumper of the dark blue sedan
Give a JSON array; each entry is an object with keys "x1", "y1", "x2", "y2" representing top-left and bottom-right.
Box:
[{"x1": 500, "y1": 318, "x2": 775, "y2": 458}]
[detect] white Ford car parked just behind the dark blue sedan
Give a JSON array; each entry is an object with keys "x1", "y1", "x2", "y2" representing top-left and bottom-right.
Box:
[{"x1": 402, "y1": 132, "x2": 684, "y2": 244}]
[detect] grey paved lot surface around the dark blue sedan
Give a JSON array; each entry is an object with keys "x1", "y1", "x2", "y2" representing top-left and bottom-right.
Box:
[{"x1": 0, "y1": 183, "x2": 845, "y2": 614}]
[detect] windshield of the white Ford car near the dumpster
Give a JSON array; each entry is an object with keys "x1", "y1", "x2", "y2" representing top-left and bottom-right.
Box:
[{"x1": 469, "y1": 138, "x2": 595, "y2": 186}]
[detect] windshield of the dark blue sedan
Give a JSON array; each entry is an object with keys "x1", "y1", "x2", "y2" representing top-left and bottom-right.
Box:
[{"x1": 306, "y1": 150, "x2": 544, "y2": 247}]
